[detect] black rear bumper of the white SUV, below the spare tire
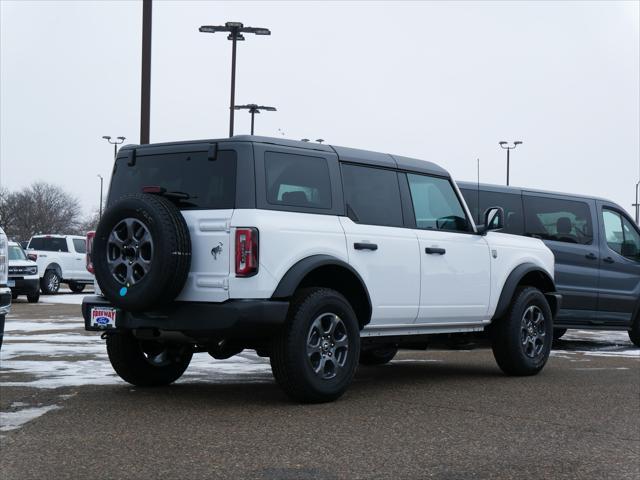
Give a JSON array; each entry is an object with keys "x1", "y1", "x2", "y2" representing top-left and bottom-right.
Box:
[{"x1": 82, "y1": 296, "x2": 289, "y2": 339}]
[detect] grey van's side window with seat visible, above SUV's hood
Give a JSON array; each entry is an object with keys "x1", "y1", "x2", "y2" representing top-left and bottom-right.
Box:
[{"x1": 524, "y1": 195, "x2": 593, "y2": 245}]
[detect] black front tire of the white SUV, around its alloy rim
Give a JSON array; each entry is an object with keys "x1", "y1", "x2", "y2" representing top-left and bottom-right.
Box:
[{"x1": 490, "y1": 287, "x2": 553, "y2": 376}]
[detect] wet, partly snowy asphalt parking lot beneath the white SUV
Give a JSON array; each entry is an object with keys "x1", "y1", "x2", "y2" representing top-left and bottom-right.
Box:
[{"x1": 0, "y1": 294, "x2": 640, "y2": 480}]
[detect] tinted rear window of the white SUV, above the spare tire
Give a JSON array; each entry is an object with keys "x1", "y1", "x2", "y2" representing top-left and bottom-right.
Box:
[{"x1": 108, "y1": 150, "x2": 236, "y2": 210}]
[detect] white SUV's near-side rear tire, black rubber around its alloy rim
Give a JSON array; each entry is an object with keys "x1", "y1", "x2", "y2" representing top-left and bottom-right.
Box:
[{"x1": 270, "y1": 288, "x2": 360, "y2": 403}]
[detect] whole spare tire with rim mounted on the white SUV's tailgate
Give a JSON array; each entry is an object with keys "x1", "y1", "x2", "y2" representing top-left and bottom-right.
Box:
[{"x1": 92, "y1": 193, "x2": 191, "y2": 310}]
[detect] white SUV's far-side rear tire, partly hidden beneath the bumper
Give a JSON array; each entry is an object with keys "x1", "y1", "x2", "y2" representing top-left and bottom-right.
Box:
[{"x1": 107, "y1": 332, "x2": 193, "y2": 387}]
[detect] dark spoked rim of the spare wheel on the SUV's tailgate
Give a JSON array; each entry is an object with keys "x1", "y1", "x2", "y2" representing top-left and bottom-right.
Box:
[{"x1": 107, "y1": 218, "x2": 153, "y2": 287}]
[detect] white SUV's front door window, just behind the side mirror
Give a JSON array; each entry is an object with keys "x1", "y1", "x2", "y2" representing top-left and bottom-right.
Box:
[{"x1": 407, "y1": 173, "x2": 470, "y2": 232}]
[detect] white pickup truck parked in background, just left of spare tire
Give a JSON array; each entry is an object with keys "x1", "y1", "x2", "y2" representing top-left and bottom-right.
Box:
[{"x1": 27, "y1": 235, "x2": 93, "y2": 295}]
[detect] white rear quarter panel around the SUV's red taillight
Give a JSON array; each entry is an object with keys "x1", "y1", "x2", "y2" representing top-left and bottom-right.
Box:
[{"x1": 229, "y1": 209, "x2": 348, "y2": 299}]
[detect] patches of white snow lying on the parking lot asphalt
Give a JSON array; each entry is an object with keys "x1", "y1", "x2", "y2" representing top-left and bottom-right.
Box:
[{"x1": 0, "y1": 316, "x2": 640, "y2": 437}]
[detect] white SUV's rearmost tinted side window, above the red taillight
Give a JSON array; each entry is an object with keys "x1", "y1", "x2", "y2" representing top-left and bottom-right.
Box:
[{"x1": 264, "y1": 152, "x2": 331, "y2": 209}]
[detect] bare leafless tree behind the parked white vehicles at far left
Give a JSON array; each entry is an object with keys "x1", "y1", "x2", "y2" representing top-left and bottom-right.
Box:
[{"x1": 0, "y1": 182, "x2": 80, "y2": 240}]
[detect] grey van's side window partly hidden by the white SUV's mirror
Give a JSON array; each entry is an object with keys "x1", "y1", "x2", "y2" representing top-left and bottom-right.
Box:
[{"x1": 460, "y1": 188, "x2": 524, "y2": 235}]
